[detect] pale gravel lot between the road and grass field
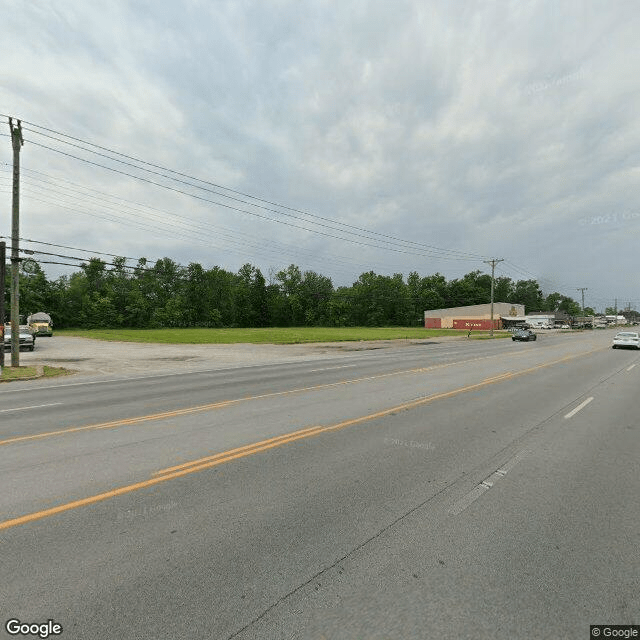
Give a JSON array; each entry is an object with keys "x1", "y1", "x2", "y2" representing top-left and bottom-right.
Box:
[{"x1": 12, "y1": 335, "x2": 448, "y2": 375}]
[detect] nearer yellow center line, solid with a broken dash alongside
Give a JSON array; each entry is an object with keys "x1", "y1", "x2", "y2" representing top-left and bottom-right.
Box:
[{"x1": 0, "y1": 347, "x2": 608, "y2": 531}]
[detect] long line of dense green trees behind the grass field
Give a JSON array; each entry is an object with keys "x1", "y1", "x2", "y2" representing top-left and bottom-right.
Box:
[{"x1": 5, "y1": 258, "x2": 593, "y2": 328}]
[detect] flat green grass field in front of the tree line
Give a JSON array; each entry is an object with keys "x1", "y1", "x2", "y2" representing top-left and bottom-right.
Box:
[{"x1": 56, "y1": 327, "x2": 510, "y2": 344}]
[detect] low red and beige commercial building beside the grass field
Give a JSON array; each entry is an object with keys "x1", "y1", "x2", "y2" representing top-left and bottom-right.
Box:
[{"x1": 424, "y1": 302, "x2": 525, "y2": 331}]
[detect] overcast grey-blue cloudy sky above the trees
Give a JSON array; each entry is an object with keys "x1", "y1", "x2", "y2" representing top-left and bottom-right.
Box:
[{"x1": 0, "y1": 0, "x2": 640, "y2": 309}]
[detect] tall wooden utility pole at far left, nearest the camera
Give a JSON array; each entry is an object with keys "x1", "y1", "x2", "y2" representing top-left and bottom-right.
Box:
[{"x1": 8, "y1": 118, "x2": 24, "y2": 367}]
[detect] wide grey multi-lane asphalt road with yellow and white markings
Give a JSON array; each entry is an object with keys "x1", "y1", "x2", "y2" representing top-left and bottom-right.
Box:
[{"x1": 0, "y1": 332, "x2": 640, "y2": 640}]
